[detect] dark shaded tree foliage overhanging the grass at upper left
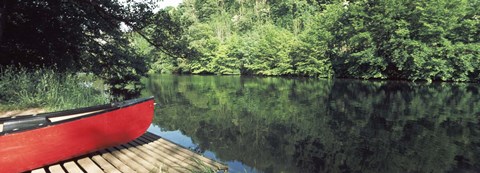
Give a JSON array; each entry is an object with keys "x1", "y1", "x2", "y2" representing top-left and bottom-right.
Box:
[{"x1": 0, "y1": 0, "x2": 153, "y2": 84}]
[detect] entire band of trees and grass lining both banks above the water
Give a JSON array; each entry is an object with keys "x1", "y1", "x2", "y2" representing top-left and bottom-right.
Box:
[{"x1": 0, "y1": 0, "x2": 480, "y2": 111}]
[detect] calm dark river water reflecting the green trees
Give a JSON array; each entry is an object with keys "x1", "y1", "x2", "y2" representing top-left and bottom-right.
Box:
[{"x1": 142, "y1": 75, "x2": 480, "y2": 173}]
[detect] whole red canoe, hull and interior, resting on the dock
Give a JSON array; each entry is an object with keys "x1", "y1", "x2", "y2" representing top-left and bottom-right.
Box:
[{"x1": 0, "y1": 98, "x2": 154, "y2": 173}]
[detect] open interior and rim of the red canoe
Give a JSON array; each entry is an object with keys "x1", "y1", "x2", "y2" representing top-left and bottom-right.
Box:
[{"x1": 0, "y1": 97, "x2": 151, "y2": 136}]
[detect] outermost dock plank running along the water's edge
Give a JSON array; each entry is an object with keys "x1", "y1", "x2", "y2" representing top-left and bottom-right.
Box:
[{"x1": 140, "y1": 133, "x2": 228, "y2": 170}]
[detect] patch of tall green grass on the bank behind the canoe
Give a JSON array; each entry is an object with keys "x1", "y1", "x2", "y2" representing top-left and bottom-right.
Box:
[{"x1": 0, "y1": 67, "x2": 110, "y2": 111}]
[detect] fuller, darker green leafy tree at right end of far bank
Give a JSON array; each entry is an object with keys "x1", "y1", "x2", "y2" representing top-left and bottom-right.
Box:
[{"x1": 331, "y1": 0, "x2": 480, "y2": 81}]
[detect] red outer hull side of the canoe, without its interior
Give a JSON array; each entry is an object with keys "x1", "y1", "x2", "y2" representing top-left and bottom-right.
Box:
[{"x1": 0, "y1": 99, "x2": 154, "y2": 173}]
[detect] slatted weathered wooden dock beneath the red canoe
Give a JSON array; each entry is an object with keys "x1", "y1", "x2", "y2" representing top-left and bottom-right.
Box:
[{"x1": 31, "y1": 132, "x2": 228, "y2": 173}]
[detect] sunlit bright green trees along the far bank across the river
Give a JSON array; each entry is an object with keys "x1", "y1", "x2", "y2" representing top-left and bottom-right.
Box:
[{"x1": 145, "y1": 0, "x2": 480, "y2": 82}]
